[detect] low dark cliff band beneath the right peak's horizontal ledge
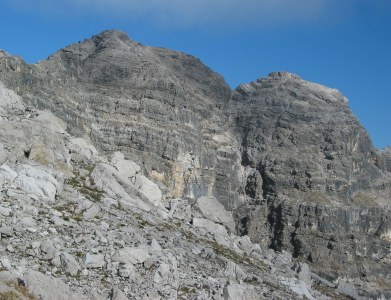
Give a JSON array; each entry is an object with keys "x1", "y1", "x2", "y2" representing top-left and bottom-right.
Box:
[{"x1": 236, "y1": 200, "x2": 391, "y2": 284}]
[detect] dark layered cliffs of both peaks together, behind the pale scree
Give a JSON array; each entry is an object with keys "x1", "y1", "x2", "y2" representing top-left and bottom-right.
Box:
[{"x1": 0, "y1": 31, "x2": 391, "y2": 296}]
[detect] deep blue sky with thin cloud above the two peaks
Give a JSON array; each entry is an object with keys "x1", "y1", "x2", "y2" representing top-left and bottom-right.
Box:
[{"x1": 0, "y1": 0, "x2": 391, "y2": 148}]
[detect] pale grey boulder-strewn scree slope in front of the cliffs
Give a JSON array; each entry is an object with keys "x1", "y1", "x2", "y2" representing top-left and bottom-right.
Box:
[{"x1": 0, "y1": 80, "x2": 321, "y2": 300}]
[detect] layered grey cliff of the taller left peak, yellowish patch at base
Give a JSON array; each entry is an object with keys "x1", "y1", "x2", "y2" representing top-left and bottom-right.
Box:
[{"x1": 0, "y1": 31, "x2": 240, "y2": 209}]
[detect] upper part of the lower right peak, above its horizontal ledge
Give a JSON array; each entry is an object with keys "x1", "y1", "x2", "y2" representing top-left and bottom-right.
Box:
[{"x1": 234, "y1": 73, "x2": 385, "y2": 203}]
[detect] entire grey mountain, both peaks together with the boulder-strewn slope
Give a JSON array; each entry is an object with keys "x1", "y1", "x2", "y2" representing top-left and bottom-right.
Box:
[{"x1": 0, "y1": 30, "x2": 391, "y2": 299}]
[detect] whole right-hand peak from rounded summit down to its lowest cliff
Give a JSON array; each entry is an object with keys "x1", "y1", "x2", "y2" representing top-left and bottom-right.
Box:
[{"x1": 233, "y1": 73, "x2": 391, "y2": 290}]
